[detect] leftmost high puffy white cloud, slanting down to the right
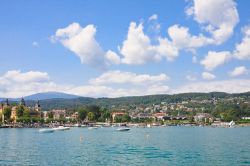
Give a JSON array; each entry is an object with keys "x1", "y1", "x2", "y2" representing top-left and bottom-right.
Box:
[{"x1": 51, "y1": 23, "x2": 119, "y2": 68}]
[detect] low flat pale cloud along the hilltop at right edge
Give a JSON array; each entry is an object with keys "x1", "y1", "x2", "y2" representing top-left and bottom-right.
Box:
[{"x1": 172, "y1": 79, "x2": 250, "y2": 93}]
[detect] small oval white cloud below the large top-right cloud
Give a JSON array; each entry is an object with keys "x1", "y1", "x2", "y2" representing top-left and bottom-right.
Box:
[{"x1": 200, "y1": 51, "x2": 231, "y2": 70}]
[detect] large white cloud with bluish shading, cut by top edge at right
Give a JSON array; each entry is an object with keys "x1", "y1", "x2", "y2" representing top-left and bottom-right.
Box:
[{"x1": 186, "y1": 0, "x2": 239, "y2": 44}]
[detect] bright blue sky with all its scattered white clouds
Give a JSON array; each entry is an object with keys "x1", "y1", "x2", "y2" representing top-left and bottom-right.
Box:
[{"x1": 0, "y1": 0, "x2": 250, "y2": 97}]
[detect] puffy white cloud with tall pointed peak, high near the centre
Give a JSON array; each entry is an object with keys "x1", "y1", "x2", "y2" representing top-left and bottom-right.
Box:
[{"x1": 120, "y1": 22, "x2": 178, "y2": 64}]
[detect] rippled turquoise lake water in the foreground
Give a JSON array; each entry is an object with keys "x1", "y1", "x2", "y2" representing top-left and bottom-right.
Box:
[{"x1": 0, "y1": 127, "x2": 250, "y2": 166}]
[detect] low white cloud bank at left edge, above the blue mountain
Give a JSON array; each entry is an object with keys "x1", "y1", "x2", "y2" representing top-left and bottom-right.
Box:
[{"x1": 0, "y1": 70, "x2": 66, "y2": 97}]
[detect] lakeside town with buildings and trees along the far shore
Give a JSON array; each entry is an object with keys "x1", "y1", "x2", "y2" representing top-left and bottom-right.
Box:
[{"x1": 0, "y1": 97, "x2": 250, "y2": 128}]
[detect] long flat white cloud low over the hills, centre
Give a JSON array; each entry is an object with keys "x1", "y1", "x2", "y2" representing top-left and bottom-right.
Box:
[{"x1": 68, "y1": 70, "x2": 170, "y2": 97}]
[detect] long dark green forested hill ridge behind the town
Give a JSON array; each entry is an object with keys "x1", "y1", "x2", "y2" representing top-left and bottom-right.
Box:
[{"x1": 16, "y1": 92, "x2": 250, "y2": 110}]
